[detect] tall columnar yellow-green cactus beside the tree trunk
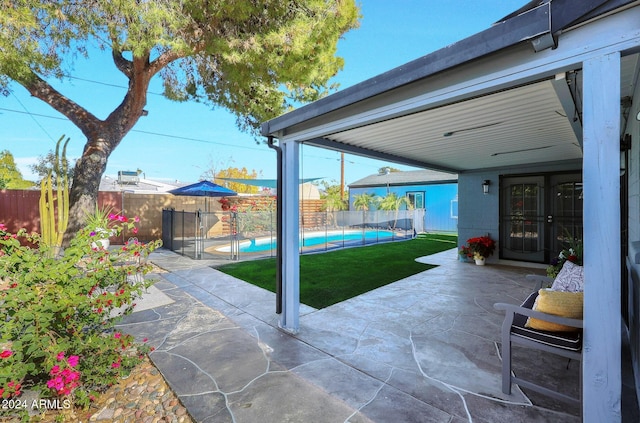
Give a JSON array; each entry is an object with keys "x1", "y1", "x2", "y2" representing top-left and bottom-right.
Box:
[{"x1": 40, "y1": 135, "x2": 70, "y2": 253}]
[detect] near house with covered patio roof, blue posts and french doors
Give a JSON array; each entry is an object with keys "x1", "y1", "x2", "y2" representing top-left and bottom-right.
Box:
[{"x1": 262, "y1": 0, "x2": 640, "y2": 422}]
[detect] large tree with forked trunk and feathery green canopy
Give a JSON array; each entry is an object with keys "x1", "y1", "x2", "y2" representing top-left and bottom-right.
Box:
[{"x1": 0, "y1": 0, "x2": 359, "y2": 243}]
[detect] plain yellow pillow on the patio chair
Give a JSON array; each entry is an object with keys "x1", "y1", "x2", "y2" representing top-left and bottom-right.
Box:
[{"x1": 525, "y1": 289, "x2": 584, "y2": 332}]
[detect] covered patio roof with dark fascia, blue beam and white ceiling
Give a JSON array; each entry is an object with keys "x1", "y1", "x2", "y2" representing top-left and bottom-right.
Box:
[{"x1": 262, "y1": 1, "x2": 640, "y2": 173}]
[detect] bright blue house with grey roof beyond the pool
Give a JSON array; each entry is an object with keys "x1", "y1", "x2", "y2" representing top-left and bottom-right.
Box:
[{"x1": 349, "y1": 170, "x2": 458, "y2": 232}]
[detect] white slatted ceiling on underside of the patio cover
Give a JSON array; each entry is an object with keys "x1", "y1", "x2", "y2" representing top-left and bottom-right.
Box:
[{"x1": 302, "y1": 54, "x2": 640, "y2": 171}]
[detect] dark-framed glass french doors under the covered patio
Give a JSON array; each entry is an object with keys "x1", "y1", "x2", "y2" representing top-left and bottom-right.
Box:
[{"x1": 500, "y1": 173, "x2": 582, "y2": 263}]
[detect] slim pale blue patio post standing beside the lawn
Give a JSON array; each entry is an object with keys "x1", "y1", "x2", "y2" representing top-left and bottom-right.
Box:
[{"x1": 278, "y1": 139, "x2": 300, "y2": 333}]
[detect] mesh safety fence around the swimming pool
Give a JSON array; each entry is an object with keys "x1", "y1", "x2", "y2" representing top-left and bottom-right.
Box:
[{"x1": 162, "y1": 209, "x2": 424, "y2": 260}]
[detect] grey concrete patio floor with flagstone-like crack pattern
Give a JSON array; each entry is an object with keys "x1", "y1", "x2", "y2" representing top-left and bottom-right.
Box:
[{"x1": 116, "y1": 249, "x2": 632, "y2": 423}]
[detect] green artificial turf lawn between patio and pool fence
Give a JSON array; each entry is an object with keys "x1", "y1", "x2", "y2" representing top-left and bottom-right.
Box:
[{"x1": 217, "y1": 234, "x2": 457, "y2": 308}]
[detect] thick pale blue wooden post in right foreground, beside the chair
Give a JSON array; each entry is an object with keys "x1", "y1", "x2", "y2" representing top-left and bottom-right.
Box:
[{"x1": 582, "y1": 52, "x2": 622, "y2": 423}]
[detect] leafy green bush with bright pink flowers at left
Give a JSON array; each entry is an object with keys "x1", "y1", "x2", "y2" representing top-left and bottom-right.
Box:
[{"x1": 0, "y1": 215, "x2": 160, "y2": 412}]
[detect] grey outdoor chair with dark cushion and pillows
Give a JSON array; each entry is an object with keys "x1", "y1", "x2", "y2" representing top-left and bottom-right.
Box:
[{"x1": 494, "y1": 275, "x2": 583, "y2": 406}]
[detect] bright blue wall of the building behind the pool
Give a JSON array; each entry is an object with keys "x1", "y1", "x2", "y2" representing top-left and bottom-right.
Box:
[{"x1": 349, "y1": 183, "x2": 458, "y2": 233}]
